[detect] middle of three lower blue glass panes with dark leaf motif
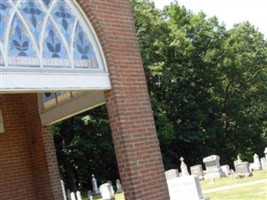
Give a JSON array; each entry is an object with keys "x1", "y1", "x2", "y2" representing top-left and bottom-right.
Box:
[{"x1": 43, "y1": 22, "x2": 67, "y2": 59}]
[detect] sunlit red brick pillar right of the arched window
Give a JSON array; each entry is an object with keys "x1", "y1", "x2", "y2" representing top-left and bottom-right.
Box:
[{"x1": 77, "y1": 0, "x2": 169, "y2": 200}]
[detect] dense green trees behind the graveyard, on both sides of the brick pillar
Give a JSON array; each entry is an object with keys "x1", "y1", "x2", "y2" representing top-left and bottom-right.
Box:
[{"x1": 52, "y1": 0, "x2": 267, "y2": 192}]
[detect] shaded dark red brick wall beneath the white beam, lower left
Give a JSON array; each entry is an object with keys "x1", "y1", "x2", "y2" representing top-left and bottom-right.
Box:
[{"x1": 0, "y1": 94, "x2": 62, "y2": 200}]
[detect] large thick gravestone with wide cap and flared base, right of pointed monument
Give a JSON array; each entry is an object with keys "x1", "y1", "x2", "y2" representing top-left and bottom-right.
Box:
[{"x1": 203, "y1": 155, "x2": 225, "y2": 180}]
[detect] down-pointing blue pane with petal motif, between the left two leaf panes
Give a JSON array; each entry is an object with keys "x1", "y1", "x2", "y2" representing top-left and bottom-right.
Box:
[{"x1": 20, "y1": 0, "x2": 44, "y2": 44}]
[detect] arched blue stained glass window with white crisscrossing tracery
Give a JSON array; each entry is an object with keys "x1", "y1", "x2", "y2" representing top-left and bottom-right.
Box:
[{"x1": 0, "y1": 0, "x2": 106, "y2": 72}]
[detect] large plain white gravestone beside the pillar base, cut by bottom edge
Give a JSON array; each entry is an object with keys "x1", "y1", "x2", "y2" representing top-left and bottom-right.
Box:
[{"x1": 167, "y1": 176, "x2": 208, "y2": 200}]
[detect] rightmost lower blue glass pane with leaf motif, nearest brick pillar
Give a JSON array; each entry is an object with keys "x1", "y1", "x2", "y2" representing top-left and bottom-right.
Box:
[{"x1": 74, "y1": 24, "x2": 95, "y2": 60}]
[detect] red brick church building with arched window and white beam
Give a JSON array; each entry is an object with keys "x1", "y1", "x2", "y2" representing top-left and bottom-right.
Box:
[{"x1": 0, "y1": 0, "x2": 169, "y2": 200}]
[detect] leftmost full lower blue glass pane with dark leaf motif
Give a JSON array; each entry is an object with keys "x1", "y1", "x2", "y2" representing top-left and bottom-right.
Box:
[{"x1": 9, "y1": 16, "x2": 36, "y2": 57}]
